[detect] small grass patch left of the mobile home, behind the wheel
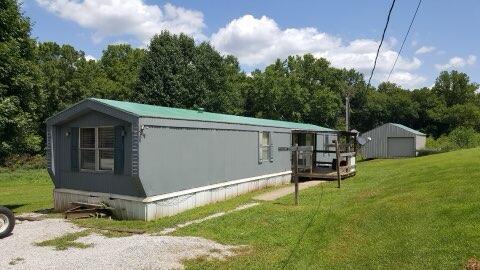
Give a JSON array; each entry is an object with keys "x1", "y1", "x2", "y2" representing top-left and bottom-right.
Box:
[{"x1": 0, "y1": 168, "x2": 53, "y2": 213}]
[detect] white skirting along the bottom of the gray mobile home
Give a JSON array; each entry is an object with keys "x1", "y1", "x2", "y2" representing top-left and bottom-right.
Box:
[{"x1": 54, "y1": 172, "x2": 291, "y2": 221}]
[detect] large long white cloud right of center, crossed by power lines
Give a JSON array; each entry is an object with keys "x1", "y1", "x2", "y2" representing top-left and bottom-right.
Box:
[{"x1": 211, "y1": 15, "x2": 422, "y2": 86}]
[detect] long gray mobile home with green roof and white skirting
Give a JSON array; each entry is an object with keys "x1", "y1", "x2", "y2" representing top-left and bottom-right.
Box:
[{"x1": 46, "y1": 98, "x2": 354, "y2": 220}]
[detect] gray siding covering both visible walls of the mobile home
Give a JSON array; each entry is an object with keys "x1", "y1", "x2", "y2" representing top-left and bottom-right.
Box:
[{"x1": 46, "y1": 101, "x2": 335, "y2": 198}]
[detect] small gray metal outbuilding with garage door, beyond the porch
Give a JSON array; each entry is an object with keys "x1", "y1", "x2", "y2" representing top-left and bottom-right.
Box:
[{"x1": 362, "y1": 123, "x2": 426, "y2": 159}]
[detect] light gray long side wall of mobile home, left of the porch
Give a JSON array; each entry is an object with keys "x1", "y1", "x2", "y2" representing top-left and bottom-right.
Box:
[{"x1": 139, "y1": 118, "x2": 291, "y2": 196}]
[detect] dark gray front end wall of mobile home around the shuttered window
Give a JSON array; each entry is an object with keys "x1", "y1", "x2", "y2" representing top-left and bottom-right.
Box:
[{"x1": 51, "y1": 111, "x2": 145, "y2": 197}]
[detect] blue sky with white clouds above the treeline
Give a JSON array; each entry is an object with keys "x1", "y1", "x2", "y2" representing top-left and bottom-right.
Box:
[{"x1": 23, "y1": 0, "x2": 480, "y2": 88}]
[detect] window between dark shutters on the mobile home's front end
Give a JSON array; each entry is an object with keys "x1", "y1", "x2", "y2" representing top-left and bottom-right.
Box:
[{"x1": 80, "y1": 127, "x2": 114, "y2": 171}]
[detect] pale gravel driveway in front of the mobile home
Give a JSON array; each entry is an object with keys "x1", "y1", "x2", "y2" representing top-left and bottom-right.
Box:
[{"x1": 0, "y1": 216, "x2": 239, "y2": 270}]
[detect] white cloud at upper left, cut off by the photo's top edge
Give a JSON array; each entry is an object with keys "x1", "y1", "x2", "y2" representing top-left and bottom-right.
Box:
[{"x1": 36, "y1": 0, "x2": 205, "y2": 44}]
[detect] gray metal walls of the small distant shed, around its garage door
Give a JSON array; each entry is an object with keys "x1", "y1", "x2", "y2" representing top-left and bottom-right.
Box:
[{"x1": 362, "y1": 124, "x2": 425, "y2": 158}]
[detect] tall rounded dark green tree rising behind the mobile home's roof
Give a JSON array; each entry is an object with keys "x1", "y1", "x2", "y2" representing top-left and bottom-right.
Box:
[{"x1": 134, "y1": 31, "x2": 244, "y2": 112}]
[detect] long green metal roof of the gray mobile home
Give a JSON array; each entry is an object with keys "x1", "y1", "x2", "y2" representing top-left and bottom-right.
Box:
[{"x1": 90, "y1": 98, "x2": 333, "y2": 131}]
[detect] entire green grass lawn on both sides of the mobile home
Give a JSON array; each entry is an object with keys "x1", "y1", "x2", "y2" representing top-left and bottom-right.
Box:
[{"x1": 0, "y1": 149, "x2": 480, "y2": 269}]
